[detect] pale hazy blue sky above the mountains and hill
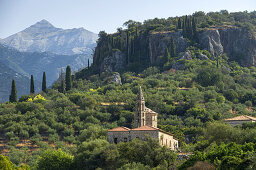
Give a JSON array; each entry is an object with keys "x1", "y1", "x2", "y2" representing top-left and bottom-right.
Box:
[{"x1": 0, "y1": 0, "x2": 256, "y2": 38}]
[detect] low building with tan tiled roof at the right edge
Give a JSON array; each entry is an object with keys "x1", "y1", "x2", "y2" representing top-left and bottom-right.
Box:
[{"x1": 224, "y1": 115, "x2": 256, "y2": 126}]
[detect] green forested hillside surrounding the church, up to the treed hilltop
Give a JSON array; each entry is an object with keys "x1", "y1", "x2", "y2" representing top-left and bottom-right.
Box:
[{"x1": 0, "y1": 11, "x2": 256, "y2": 169}]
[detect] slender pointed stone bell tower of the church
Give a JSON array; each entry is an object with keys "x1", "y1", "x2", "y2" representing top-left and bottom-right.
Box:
[{"x1": 134, "y1": 86, "x2": 146, "y2": 128}]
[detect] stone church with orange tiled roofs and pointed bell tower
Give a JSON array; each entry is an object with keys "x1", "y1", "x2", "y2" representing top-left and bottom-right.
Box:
[{"x1": 107, "y1": 87, "x2": 178, "y2": 150}]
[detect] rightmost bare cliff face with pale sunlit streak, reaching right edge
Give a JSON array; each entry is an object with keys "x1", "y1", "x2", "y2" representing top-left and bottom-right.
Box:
[{"x1": 198, "y1": 26, "x2": 256, "y2": 66}]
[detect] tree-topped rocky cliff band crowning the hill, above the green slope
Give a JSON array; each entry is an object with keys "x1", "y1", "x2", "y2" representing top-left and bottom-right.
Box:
[{"x1": 85, "y1": 11, "x2": 256, "y2": 76}]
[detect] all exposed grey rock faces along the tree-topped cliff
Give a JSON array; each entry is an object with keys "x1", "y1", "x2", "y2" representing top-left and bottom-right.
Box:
[{"x1": 94, "y1": 26, "x2": 256, "y2": 72}]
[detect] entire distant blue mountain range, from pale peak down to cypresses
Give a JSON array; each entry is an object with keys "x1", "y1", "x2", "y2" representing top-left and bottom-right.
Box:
[{"x1": 0, "y1": 20, "x2": 97, "y2": 102}]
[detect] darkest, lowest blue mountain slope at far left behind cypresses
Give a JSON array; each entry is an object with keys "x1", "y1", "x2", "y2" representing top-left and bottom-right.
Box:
[{"x1": 0, "y1": 62, "x2": 40, "y2": 102}]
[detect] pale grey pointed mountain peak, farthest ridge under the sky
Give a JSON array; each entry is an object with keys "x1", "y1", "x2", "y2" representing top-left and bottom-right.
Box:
[{"x1": 0, "y1": 20, "x2": 97, "y2": 55}]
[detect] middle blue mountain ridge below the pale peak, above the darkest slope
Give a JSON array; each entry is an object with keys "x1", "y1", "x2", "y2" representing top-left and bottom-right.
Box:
[{"x1": 0, "y1": 45, "x2": 90, "y2": 86}]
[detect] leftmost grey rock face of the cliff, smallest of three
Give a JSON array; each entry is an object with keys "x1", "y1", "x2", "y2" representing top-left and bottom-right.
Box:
[{"x1": 101, "y1": 51, "x2": 126, "y2": 72}]
